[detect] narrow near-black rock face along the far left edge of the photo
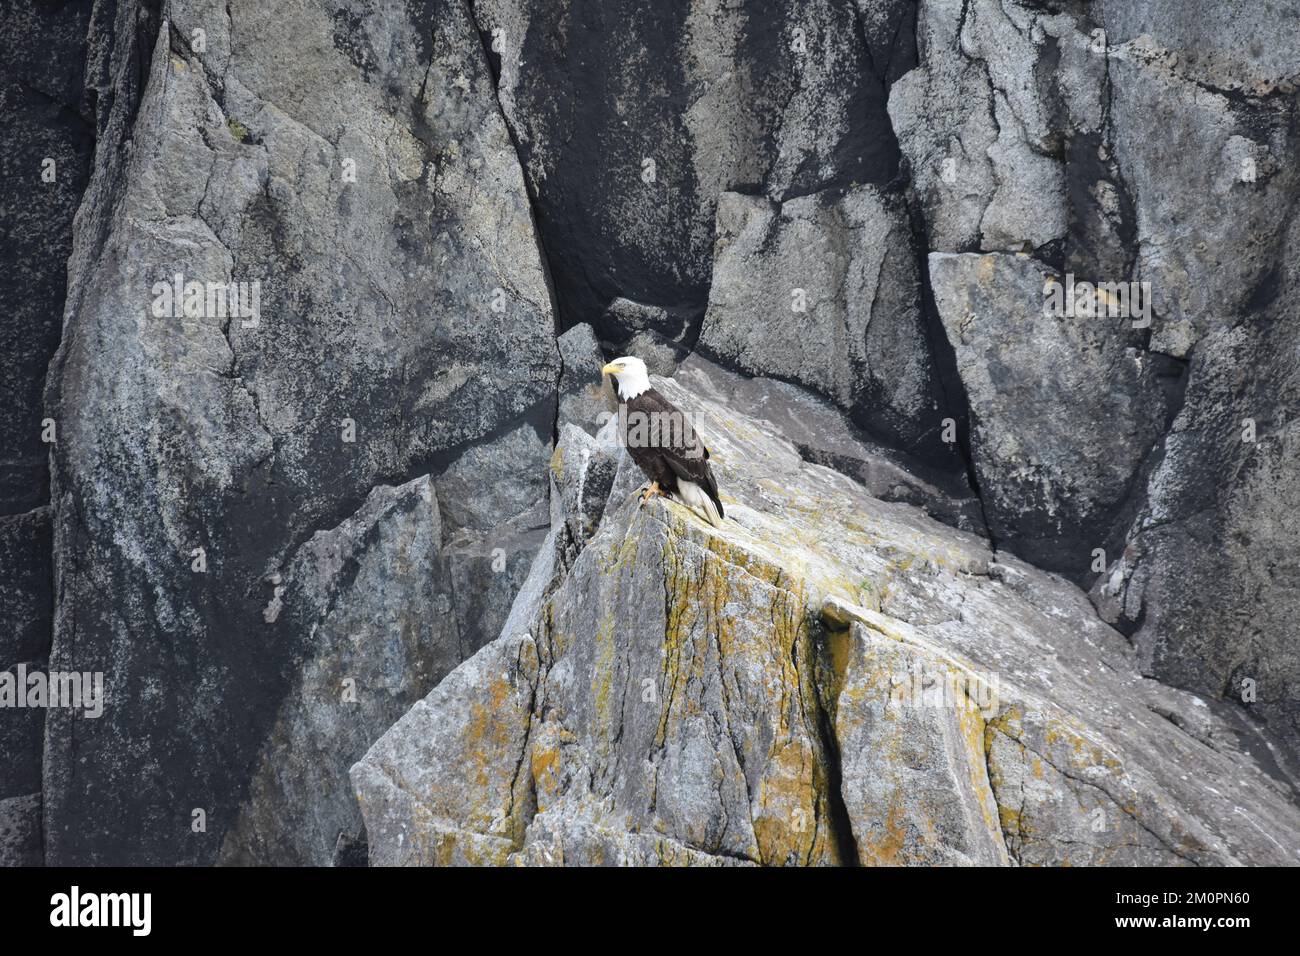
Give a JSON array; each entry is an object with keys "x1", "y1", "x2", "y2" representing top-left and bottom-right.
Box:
[{"x1": 0, "y1": 0, "x2": 95, "y2": 866}]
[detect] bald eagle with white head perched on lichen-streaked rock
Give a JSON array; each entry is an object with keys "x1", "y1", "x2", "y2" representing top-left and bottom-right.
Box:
[{"x1": 601, "y1": 355, "x2": 725, "y2": 527}]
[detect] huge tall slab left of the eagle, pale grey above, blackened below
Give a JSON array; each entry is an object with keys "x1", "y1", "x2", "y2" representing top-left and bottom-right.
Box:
[{"x1": 46, "y1": 0, "x2": 559, "y2": 864}]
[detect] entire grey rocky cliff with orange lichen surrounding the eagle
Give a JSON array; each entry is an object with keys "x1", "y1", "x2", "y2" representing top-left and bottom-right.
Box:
[{"x1": 0, "y1": 0, "x2": 1300, "y2": 865}]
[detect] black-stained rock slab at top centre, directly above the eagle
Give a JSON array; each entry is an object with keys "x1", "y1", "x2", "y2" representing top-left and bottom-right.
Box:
[{"x1": 475, "y1": 0, "x2": 907, "y2": 342}]
